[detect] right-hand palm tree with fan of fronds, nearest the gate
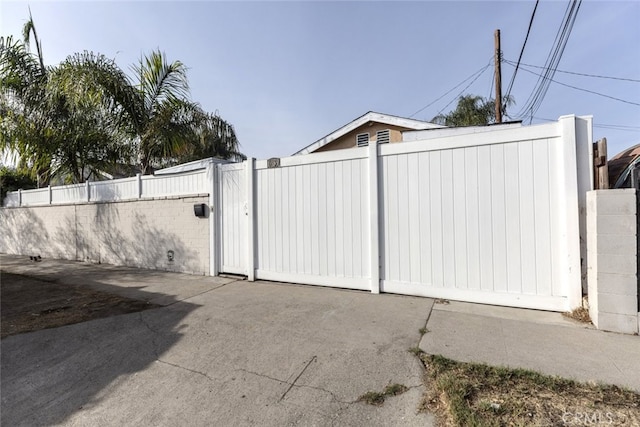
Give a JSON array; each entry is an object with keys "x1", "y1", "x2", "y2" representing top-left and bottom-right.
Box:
[{"x1": 60, "y1": 50, "x2": 239, "y2": 174}]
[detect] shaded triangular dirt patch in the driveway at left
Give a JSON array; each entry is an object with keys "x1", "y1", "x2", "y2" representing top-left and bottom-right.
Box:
[{"x1": 0, "y1": 271, "x2": 159, "y2": 338}]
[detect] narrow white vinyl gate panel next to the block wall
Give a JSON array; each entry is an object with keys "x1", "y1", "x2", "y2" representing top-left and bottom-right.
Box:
[{"x1": 218, "y1": 163, "x2": 248, "y2": 274}]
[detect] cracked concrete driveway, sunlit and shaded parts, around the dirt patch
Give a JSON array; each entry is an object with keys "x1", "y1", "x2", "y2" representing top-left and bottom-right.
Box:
[{"x1": 1, "y1": 256, "x2": 433, "y2": 426}]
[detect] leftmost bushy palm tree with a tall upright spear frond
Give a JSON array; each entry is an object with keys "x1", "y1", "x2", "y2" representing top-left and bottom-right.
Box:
[{"x1": 0, "y1": 14, "x2": 122, "y2": 186}]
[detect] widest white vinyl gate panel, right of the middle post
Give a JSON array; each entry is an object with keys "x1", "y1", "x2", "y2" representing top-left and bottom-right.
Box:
[{"x1": 381, "y1": 130, "x2": 568, "y2": 310}]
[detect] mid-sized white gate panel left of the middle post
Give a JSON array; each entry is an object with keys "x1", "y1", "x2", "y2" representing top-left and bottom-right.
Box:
[{"x1": 254, "y1": 153, "x2": 370, "y2": 289}]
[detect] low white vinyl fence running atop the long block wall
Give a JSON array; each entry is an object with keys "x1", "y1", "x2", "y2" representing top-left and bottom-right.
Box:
[{"x1": 4, "y1": 170, "x2": 209, "y2": 207}]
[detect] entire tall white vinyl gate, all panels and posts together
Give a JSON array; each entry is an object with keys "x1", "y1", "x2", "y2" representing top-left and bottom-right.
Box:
[{"x1": 218, "y1": 116, "x2": 591, "y2": 311}]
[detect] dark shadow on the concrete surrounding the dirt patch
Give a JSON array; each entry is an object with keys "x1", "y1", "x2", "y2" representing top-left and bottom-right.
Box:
[{"x1": 0, "y1": 256, "x2": 204, "y2": 426}]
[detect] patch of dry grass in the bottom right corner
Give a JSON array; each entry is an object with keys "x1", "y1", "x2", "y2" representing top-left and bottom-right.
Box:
[{"x1": 421, "y1": 354, "x2": 640, "y2": 426}]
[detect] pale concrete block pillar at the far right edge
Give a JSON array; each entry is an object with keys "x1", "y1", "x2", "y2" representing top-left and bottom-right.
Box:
[{"x1": 587, "y1": 189, "x2": 640, "y2": 334}]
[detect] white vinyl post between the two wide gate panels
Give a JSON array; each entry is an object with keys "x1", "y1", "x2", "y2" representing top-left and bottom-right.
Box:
[{"x1": 369, "y1": 141, "x2": 380, "y2": 294}]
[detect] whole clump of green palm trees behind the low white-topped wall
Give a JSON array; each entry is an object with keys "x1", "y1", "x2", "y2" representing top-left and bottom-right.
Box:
[{"x1": 0, "y1": 13, "x2": 244, "y2": 181}]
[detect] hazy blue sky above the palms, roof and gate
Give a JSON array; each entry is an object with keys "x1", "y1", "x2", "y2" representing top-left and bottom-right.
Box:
[{"x1": 0, "y1": 0, "x2": 640, "y2": 158}]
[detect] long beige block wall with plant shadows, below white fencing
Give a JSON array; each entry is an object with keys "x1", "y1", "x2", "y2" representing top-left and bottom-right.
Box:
[{"x1": 0, "y1": 195, "x2": 209, "y2": 274}]
